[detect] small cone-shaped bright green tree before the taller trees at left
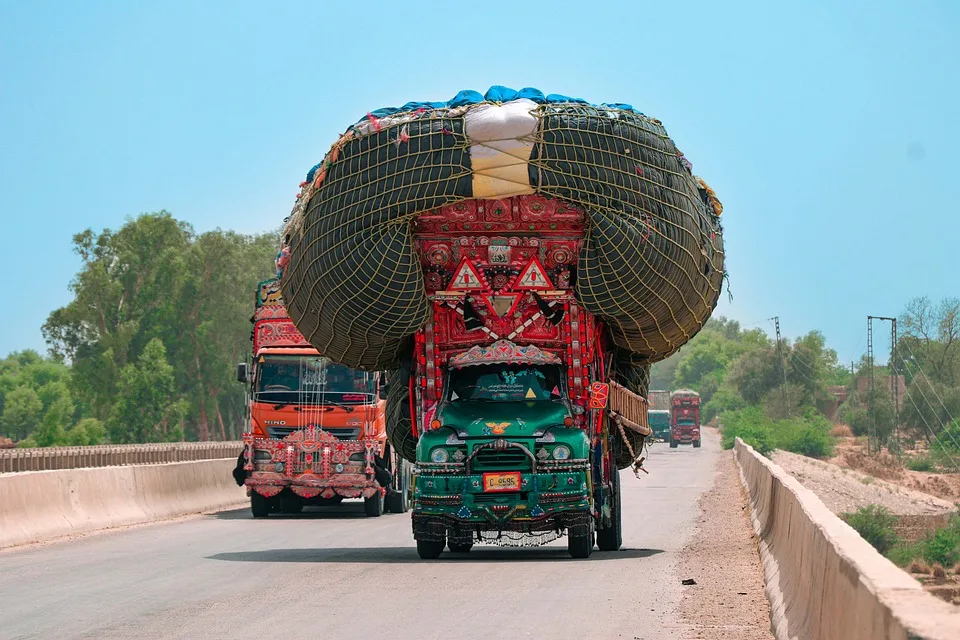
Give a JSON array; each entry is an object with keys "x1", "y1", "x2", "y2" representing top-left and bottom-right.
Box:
[{"x1": 107, "y1": 338, "x2": 186, "y2": 443}]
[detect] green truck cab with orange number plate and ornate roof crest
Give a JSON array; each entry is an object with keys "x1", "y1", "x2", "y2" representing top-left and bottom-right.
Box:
[{"x1": 415, "y1": 341, "x2": 593, "y2": 555}]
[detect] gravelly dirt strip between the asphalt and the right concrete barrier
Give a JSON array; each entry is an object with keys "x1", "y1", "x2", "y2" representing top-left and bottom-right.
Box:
[{"x1": 678, "y1": 436, "x2": 773, "y2": 640}]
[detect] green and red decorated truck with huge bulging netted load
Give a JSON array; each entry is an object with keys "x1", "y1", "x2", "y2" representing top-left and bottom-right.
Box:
[{"x1": 277, "y1": 87, "x2": 724, "y2": 558}]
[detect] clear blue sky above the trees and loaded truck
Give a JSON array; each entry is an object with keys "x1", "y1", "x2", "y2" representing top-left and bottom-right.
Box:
[{"x1": 0, "y1": 0, "x2": 960, "y2": 361}]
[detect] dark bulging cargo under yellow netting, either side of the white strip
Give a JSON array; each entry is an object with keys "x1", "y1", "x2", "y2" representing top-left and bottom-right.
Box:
[{"x1": 278, "y1": 103, "x2": 724, "y2": 369}]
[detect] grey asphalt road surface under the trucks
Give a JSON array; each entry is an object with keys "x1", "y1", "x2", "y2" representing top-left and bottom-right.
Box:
[{"x1": 0, "y1": 431, "x2": 719, "y2": 640}]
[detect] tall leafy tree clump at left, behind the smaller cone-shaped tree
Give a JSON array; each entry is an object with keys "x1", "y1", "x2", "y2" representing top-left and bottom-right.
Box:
[{"x1": 44, "y1": 211, "x2": 277, "y2": 440}]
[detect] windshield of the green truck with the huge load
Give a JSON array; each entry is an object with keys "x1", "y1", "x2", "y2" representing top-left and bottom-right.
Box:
[{"x1": 448, "y1": 364, "x2": 563, "y2": 402}]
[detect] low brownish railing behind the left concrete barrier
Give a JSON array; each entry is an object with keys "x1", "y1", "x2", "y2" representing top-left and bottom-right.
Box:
[{"x1": 0, "y1": 441, "x2": 243, "y2": 473}]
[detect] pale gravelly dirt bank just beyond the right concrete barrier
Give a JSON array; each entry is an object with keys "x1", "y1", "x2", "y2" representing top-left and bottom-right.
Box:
[{"x1": 773, "y1": 451, "x2": 956, "y2": 516}]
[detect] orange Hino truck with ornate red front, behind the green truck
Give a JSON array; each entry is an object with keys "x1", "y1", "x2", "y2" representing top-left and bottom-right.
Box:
[{"x1": 233, "y1": 279, "x2": 412, "y2": 518}]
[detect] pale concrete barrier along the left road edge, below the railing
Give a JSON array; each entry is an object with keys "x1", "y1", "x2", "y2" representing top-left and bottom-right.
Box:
[{"x1": 0, "y1": 458, "x2": 247, "y2": 549}]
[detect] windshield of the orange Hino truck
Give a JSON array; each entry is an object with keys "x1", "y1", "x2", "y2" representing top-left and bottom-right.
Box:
[{"x1": 254, "y1": 355, "x2": 376, "y2": 404}]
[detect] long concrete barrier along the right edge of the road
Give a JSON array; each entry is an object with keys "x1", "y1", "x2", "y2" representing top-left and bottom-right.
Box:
[{"x1": 735, "y1": 438, "x2": 960, "y2": 640}]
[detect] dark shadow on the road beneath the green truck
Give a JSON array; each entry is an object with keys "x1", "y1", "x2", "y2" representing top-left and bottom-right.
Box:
[{"x1": 206, "y1": 546, "x2": 663, "y2": 564}]
